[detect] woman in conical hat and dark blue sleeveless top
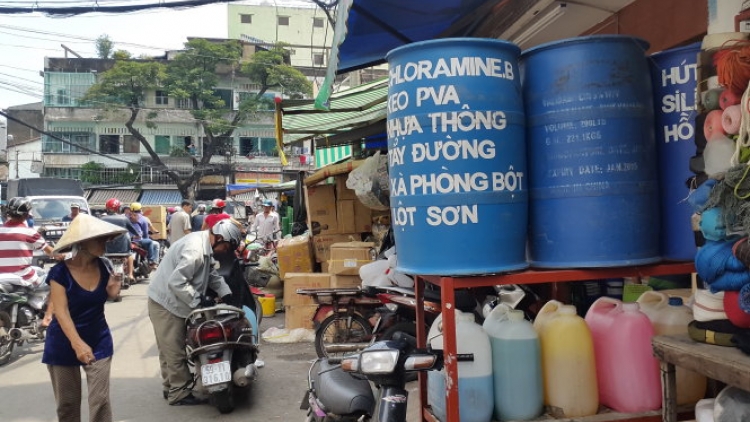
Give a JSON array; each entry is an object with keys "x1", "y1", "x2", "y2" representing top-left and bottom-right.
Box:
[{"x1": 42, "y1": 214, "x2": 125, "y2": 422}]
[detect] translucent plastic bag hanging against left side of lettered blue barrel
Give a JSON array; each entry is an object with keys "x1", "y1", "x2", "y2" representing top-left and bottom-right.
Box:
[{"x1": 346, "y1": 151, "x2": 390, "y2": 211}]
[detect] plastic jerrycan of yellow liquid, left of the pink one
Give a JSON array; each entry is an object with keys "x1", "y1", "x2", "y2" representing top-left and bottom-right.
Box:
[{"x1": 537, "y1": 302, "x2": 599, "y2": 418}]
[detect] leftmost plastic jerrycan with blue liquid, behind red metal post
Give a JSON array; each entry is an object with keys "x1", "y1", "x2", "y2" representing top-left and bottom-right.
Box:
[{"x1": 427, "y1": 310, "x2": 494, "y2": 422}]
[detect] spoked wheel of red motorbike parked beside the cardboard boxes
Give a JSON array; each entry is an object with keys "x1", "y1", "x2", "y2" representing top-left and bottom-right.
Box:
[{"x1": 315, "y1": 314, "x2": 372, "y2": 358}]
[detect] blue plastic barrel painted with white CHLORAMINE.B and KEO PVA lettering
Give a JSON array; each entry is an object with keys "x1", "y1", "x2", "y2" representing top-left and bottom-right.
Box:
[{"x1": 386, "y1": 38, "x2": 528, "y2": 275}]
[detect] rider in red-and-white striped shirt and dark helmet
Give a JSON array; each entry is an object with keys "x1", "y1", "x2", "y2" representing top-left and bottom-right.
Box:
[{"x1": 0, "y1": 197, "x2": 61, "y2": 325}]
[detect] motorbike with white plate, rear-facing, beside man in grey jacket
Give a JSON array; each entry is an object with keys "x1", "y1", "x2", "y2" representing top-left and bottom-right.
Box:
[{"x1": 186, "y1": 304, "x2": 259, "y2": 413}]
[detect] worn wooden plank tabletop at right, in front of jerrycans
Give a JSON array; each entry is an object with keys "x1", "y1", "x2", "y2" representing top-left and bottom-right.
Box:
[{"x1": 652, "y1": 335, "x2": 750, "y2": 391}]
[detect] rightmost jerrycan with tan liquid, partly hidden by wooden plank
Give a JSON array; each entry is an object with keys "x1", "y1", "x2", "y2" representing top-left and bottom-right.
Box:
[{"x1": 638, "y1": 291, "x2": 707, "y2": 405}]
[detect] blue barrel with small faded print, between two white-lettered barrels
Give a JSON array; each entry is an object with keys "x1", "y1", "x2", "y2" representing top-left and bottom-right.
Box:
[{"x1": 521, "y1": 35, "x2": 660, "y2": 268}]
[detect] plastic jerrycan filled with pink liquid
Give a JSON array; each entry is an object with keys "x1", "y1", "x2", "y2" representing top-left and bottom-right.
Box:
[{"x1": 586, "y1": 297, "x2": 661, "y2": 413}]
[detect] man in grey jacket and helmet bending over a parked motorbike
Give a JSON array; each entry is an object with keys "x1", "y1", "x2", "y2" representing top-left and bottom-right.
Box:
[{"x1": 148, "y1": 220, "x2": 241, "y2": 406}]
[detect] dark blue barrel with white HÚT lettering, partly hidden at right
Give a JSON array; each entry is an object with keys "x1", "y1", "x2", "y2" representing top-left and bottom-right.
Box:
[{"x1": 650, "y1": 43, "x2": 701, "y2": 261}]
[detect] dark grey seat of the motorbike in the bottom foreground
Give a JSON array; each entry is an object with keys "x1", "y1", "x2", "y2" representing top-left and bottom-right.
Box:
[{"x1": 312, "y1": 360, "x2": 375, "y2": 415}]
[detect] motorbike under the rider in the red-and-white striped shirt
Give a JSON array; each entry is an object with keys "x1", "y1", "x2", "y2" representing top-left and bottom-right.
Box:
[{"x1": 0, "y1": 274, "x2": 49, "y2": 365}]
